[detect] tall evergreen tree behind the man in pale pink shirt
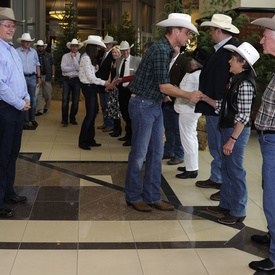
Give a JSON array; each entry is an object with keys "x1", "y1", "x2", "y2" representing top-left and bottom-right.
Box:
[{"x1": 53, "y1": 1, "x2": 78, "y2": 83}]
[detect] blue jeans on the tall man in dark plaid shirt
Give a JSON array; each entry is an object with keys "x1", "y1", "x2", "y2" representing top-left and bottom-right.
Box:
[{"x1": 125, "y1": 96, "x2": 163, "y2": 204}]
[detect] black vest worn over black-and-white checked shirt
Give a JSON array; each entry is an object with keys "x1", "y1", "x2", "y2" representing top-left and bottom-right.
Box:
[{"x1": 219, "y1": 70, "x2": 256, "y2": 128}]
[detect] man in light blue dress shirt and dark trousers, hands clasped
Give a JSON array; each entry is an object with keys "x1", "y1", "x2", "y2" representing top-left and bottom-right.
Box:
[{"x1": 0, "y1": 7, "x2": 31, "y2": 218}]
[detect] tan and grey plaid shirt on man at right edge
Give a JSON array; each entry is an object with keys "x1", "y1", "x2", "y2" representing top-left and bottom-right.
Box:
[{"x1": 255, "y1": 74, "x2": 275, "y2": 131}]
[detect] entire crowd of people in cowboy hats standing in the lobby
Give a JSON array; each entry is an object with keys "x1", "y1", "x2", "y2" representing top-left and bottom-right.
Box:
[{"x1": 0, "y1": 8, "x2": 275, "y2": 272}]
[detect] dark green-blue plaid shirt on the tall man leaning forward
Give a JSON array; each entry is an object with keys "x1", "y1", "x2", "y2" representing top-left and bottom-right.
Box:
[{"x1": 130, "y1": 36, "x2": 174, "y2": 100}]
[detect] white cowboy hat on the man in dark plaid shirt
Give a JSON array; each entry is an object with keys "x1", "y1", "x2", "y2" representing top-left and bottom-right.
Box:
[{"x1": 157, "y1": 13, "x2": 199, "y2": 34}]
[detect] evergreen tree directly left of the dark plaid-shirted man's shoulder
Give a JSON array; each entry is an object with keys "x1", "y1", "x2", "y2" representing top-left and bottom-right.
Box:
[{"x1": 106, "y1": 12, "x2": 140, "y2": 55}]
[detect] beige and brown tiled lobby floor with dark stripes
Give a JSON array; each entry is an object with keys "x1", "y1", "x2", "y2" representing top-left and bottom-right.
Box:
[{"x1": 3, "y1": 101, "x2": 268, "y2": 275}]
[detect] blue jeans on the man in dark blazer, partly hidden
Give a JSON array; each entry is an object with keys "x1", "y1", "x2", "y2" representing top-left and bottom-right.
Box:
[{"x1": 205, "y1": 116, "x2": 222, "y2": 183}]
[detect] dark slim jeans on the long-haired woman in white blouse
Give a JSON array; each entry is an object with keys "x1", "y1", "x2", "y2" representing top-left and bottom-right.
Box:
[{"x1": 78, "y1": 84, "x2": 98, "y2": 146}]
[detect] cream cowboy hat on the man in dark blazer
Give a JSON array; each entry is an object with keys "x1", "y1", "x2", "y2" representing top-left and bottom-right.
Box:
[{"x1": 201, "y1": 14, "x2": 240, "y2": 33}]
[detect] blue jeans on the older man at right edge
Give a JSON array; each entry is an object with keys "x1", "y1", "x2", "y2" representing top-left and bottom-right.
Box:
[{"x1": 258, "y1": 134, "x2": 275, "y2": 263}]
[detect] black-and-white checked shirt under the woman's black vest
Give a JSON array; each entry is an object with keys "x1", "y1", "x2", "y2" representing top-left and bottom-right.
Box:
[{"x1": 215, "y1": 79, "x2": 255, "y2": 125}]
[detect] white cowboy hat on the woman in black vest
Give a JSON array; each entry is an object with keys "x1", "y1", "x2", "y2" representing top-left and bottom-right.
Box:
[{"x1": 224, "y1": 42, "x2": 260, "y2": 75}]
